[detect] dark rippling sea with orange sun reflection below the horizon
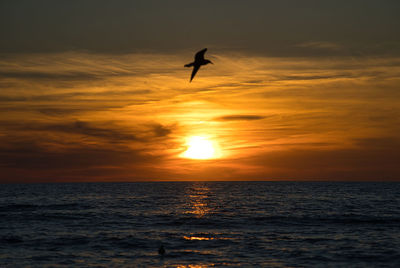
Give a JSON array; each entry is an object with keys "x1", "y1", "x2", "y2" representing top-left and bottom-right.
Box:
[{"x1": 0, "y1": 182, "x2": 400, "y2": 268}]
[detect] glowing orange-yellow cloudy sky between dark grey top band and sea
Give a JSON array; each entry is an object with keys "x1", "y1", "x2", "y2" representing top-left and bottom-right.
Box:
[{"x1": 0, "y1": 49, "x2": 400, "y2": 182}]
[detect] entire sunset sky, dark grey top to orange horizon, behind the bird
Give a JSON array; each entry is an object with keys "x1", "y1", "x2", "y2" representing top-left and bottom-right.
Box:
[{"x1": 0, "y1": 0, "x2": 400, "y2": 182}]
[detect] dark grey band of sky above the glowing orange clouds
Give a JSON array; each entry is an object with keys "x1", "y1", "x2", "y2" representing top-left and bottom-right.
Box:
[{"x1": 0, "y1": 0, "x2": 400, "y2": 56}]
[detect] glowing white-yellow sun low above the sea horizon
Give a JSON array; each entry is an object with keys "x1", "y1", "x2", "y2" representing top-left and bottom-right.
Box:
[{"x1": 183, "y1": 136, "x2": 217, "y2": 159}]
